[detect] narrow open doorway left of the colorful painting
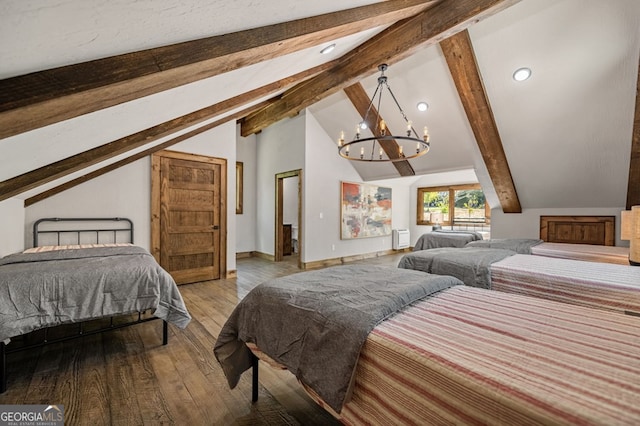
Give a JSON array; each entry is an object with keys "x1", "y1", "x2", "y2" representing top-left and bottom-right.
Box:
[{"x1": 274, "y1": 170, "x2": 302, "y2": 268}]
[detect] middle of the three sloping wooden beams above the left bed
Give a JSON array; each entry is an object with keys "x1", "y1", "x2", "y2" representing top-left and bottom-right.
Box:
[{"x1": 0, "y1": 62, "x2": 332, "y2": 201}]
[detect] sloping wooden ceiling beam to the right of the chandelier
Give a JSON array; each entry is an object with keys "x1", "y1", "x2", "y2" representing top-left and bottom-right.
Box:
[{"x1": 440, "y1": 30, "x2": 522, "y2": 213}]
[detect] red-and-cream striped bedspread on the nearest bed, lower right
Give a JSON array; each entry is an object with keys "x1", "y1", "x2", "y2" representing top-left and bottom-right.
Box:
[{"x1": 341, "y1": 286, "x2": 640, "y2": 426}]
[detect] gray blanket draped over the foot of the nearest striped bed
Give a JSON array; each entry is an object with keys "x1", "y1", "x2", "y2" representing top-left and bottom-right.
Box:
[{"x1": 214, "y1": 265, "x2": 462, "y2": 412}]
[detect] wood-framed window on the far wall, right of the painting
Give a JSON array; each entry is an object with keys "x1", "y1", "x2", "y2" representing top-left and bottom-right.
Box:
[{"x1": 417, "y1": 184, "x2": 491, "y2": 225}]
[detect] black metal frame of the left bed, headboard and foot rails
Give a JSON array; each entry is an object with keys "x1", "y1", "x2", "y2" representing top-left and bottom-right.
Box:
[{"x1": 0, "y1": 217, "x2": 169, "y2": 393}]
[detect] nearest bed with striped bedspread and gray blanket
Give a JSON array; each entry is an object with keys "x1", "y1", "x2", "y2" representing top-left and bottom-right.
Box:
[{"x1": 214, "y1": 265, "x2": 640, "y2": 425}]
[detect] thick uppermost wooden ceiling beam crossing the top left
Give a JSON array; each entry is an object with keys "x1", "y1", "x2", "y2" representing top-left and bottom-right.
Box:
[{"x1": 0, "y1": 0, "x2": 441, "y2": 139}]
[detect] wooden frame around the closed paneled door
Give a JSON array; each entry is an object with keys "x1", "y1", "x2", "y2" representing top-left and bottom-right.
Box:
[{"x1": 151, "y1": 150, "x2": 228, "y2": 278}]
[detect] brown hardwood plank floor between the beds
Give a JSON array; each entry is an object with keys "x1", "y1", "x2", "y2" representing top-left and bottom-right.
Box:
[{"x1": 0, "y1": 253, "x2": 402, "y2": 426}]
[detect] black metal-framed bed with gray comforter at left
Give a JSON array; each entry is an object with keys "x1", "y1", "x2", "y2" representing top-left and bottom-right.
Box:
[{"x1": 0, "y1": 218, "x2": 191, "y2": 392}]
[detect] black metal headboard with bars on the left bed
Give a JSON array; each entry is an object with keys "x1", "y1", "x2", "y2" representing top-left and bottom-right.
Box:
[{"x1": 33, "y1": 217, "x2": 133, "y2": 247}]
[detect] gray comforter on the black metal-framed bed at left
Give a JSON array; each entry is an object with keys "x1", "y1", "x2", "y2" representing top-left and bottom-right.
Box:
[{"x1": 0, "y1": 246, "x2": 191, "y2": 343}]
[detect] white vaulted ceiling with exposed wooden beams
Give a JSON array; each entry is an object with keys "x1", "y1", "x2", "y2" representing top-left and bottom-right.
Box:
[{"x1": 0, "y1": 0, "x2": 640, "y2": 212}]
